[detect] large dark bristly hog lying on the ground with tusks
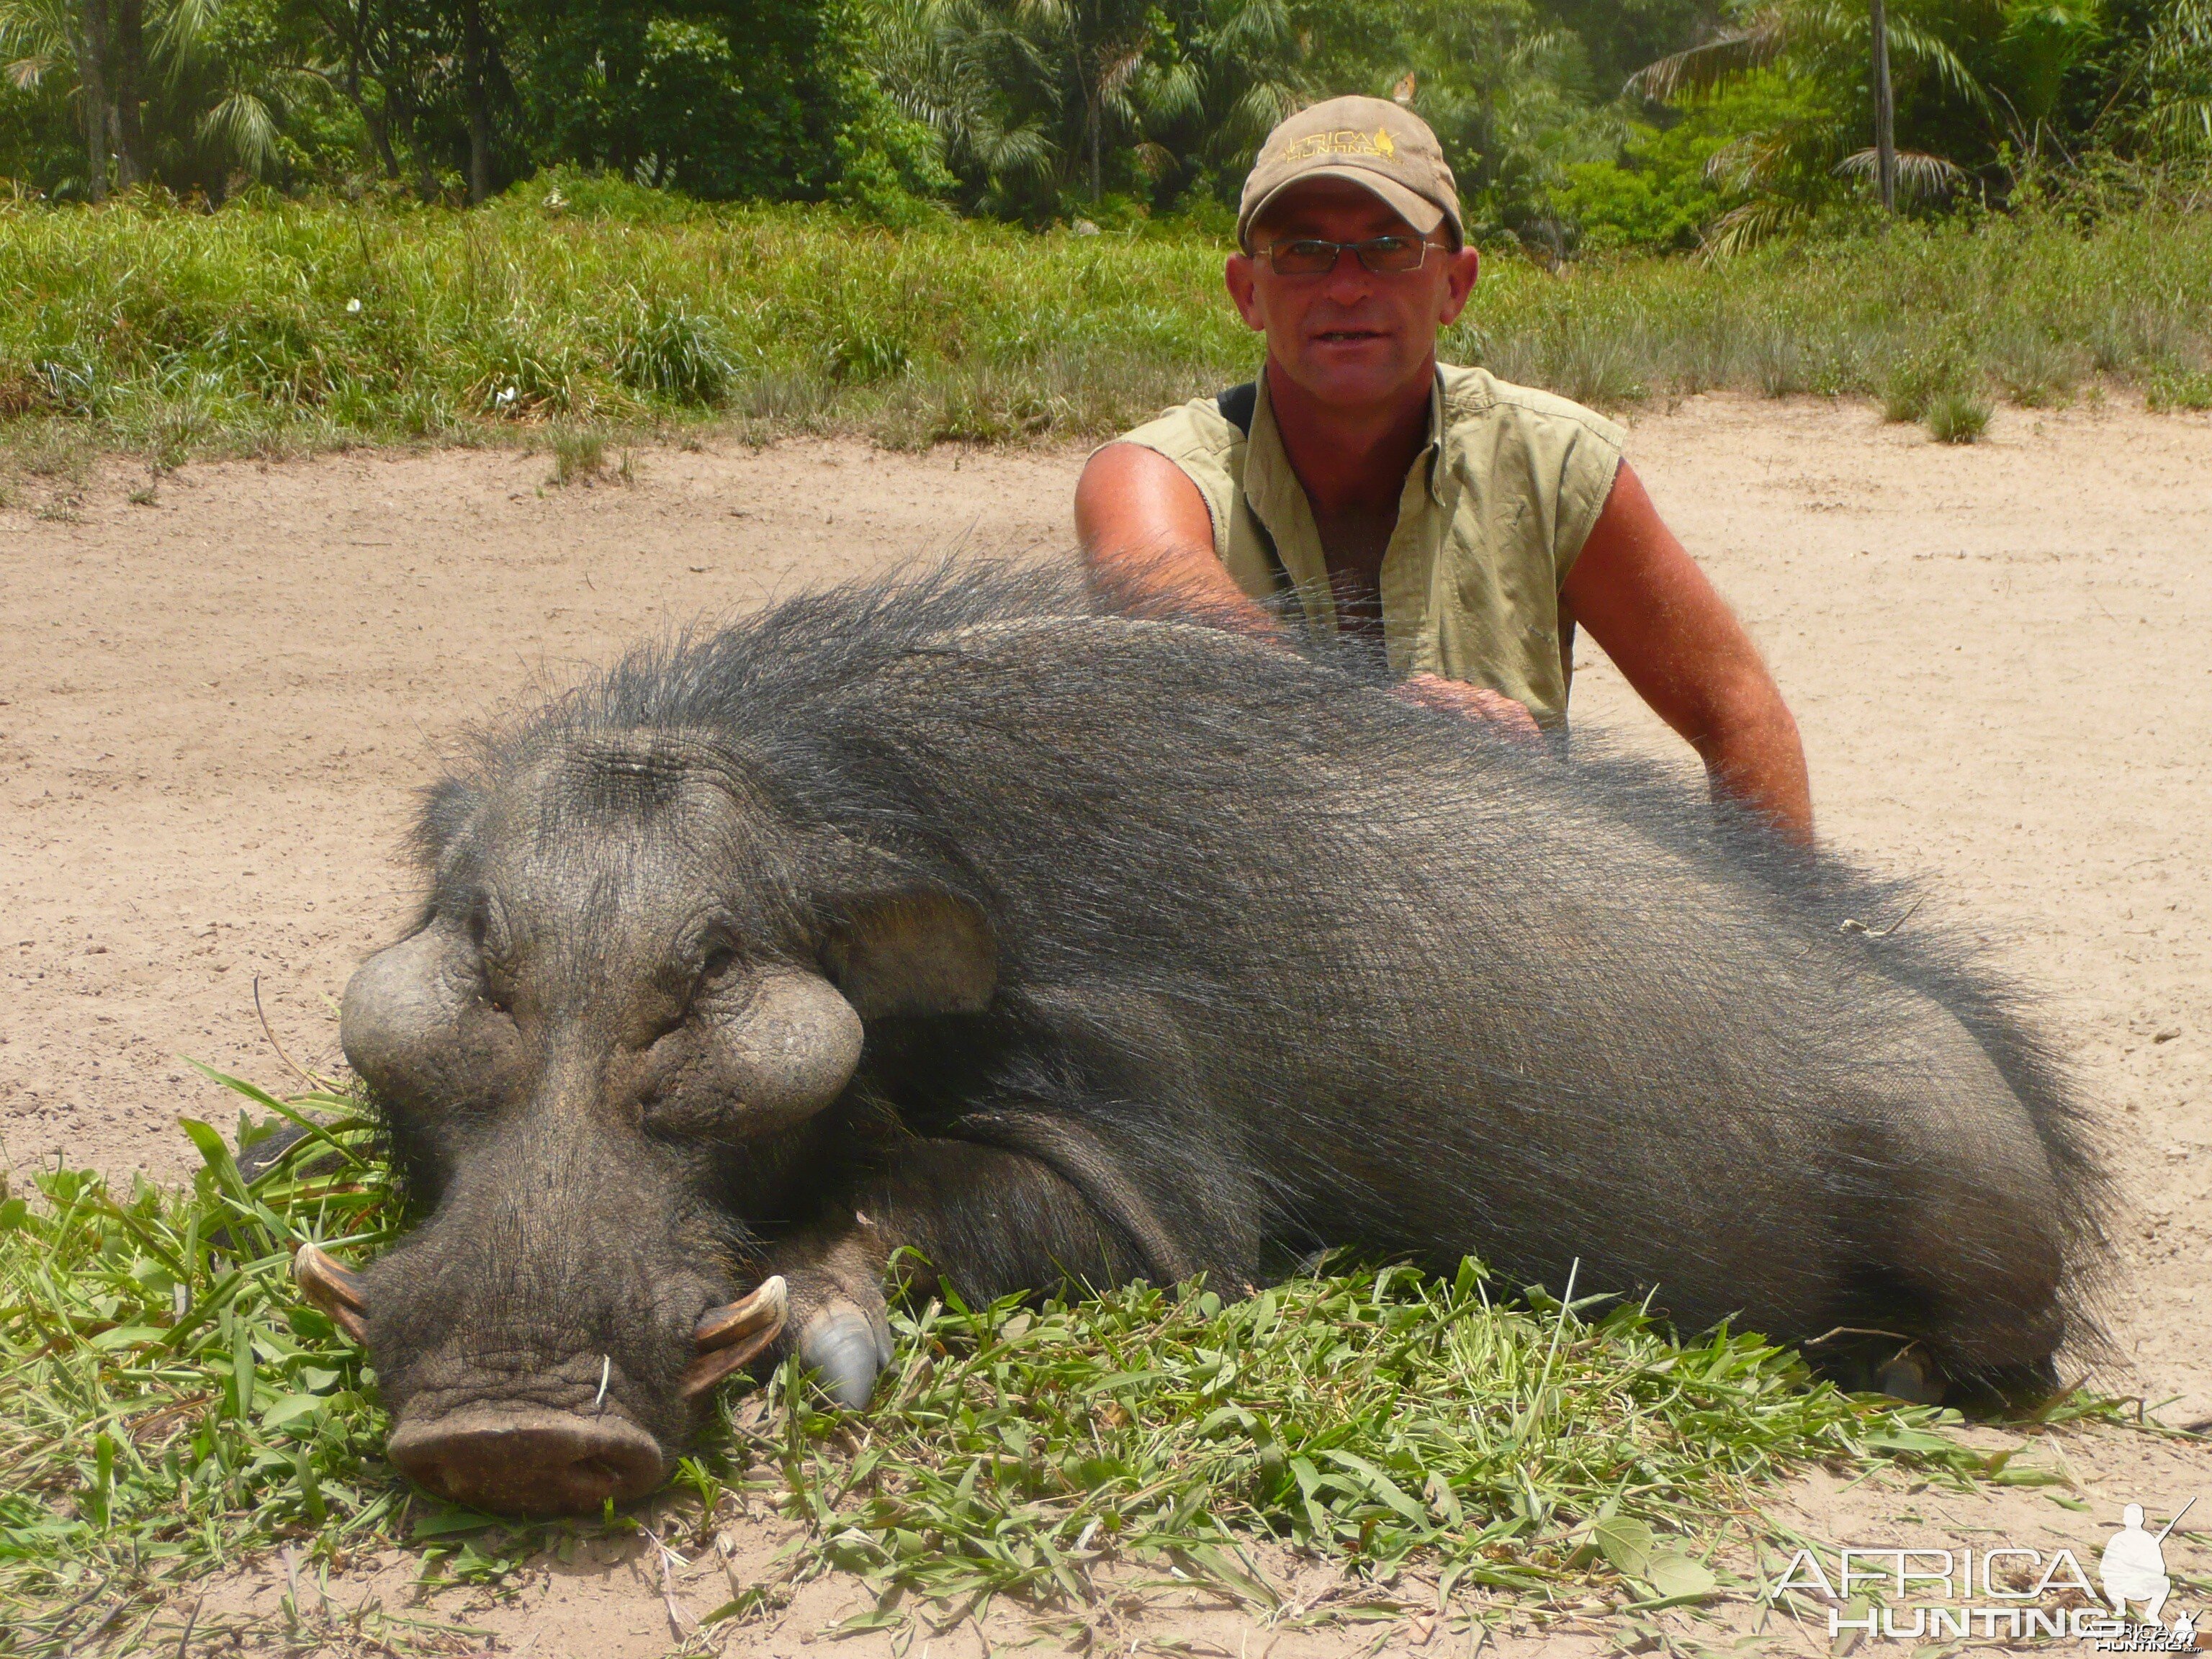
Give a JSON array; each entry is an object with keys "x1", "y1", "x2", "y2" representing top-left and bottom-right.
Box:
[{"x1": 301, "y1": 569, "x2": 2099, "y2": 1513}]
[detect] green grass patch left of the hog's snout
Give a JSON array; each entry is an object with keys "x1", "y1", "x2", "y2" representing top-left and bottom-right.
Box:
[{"x1": 0, "y1": 1079, "x2": 407, "y2": 1655}]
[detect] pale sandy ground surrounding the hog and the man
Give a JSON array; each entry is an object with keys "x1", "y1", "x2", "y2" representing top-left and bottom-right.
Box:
[{"x1": 0, "y1": 398, "x2": 2212, "y2": 1659}]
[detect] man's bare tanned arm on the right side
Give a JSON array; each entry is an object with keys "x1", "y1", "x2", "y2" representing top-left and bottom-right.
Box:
[{"x1": 1560, "y1": 460, "x2": 1812, "y2": 848}]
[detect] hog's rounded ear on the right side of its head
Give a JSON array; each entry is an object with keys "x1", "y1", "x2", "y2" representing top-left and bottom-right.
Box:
[{"x1": 823, "y1": 891, "x2": 997, "y2": 1020}]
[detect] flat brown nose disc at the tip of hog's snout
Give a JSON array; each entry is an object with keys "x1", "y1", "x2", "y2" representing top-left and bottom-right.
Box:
[{"x1": 385, "y1": 1407, "x2": 666, "y2": 1515}]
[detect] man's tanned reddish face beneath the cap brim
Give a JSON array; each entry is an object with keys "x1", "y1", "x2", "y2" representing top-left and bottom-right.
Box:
[{"x1": 1223, "y1": 179, "x2": 1480, "y2": 409}]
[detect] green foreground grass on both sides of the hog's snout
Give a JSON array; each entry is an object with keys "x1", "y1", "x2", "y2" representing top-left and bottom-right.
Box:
[{"x1": 0, "y1": 1079, "x2": 2099, "y2": 1655}]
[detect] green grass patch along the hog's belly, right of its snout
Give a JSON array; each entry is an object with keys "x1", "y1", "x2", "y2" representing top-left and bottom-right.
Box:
[{"x1": 774, "y1": 1263, "x2": 2087, "y2": 1608}]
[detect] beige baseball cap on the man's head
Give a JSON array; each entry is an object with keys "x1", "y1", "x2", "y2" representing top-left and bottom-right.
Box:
[{"x1": 1236, "y1": 97, "x2": 1467, "y2": 252}]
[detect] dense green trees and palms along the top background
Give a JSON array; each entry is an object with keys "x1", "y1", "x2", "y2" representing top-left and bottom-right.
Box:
[{"x1": 0, "y1": 0, "x2": 2212, "y2": 258}]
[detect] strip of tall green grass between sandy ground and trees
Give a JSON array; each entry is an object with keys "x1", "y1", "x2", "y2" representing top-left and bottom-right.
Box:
[{"x1": 0, "y1": 186, "x2": 2212, "y2": 467}]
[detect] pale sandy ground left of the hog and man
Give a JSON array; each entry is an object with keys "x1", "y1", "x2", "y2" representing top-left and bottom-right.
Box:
[{"x1": 0, "y1": 444, "x2": 1069, "y2": 1174}]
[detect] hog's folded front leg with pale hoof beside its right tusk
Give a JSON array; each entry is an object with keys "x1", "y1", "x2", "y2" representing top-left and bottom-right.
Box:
[{"x1": 772, "y1": 1139, "x2": 1146, "y2": 1409}]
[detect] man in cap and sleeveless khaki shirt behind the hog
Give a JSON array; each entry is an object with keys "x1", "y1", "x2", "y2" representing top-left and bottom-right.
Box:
[{"x1": 1075, "y1": 97, "x2": 1812, "y2": 845}]
